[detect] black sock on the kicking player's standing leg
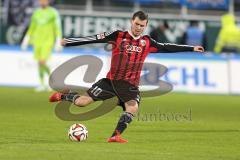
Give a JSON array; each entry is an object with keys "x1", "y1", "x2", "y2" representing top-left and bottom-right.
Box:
[{"x1": 112, "y1": 112, "x2": 133, "y2": 137}]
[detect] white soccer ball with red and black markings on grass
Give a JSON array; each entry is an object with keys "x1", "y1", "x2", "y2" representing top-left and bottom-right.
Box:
[{"x1": 68, "y1": 124, "x2": 88, "y2": 142}]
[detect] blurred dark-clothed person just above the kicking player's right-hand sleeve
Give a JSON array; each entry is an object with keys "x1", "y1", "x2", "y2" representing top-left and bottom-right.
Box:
[{"x1": 150, "y1": 21, "x2": 173, "y2": 43}]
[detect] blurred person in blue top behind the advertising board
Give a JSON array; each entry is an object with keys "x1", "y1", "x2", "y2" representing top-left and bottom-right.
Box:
[{"x1": 182, "y1": 21, "x2": 206, "y2": 48}]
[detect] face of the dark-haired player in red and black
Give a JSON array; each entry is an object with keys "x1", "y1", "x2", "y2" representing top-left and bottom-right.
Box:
[{"x1": 131, "y1": 17, "x2": 147, "y2": 36}]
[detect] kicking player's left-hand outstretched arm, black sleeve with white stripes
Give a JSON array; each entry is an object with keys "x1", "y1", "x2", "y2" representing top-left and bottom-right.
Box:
[{"x1": 61, "y1": 31, "x2": 118, "y2": 46}]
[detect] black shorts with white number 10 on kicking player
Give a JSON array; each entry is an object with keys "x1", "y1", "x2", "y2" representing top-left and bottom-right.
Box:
[{"x1": 87, "y1": 78, "x2": 141, "y2": 110}]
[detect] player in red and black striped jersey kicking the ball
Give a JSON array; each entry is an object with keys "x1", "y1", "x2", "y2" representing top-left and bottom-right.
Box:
[{"x1": 49, "y1": 11, "x2": 204, "y2": 143}]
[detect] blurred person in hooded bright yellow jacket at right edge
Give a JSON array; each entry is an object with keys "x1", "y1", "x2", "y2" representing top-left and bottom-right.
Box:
[{"x1": 214, "y1": 14, "x2": 240, "y2": 53}]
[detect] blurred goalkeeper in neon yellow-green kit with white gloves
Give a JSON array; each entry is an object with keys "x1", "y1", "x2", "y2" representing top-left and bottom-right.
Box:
[{"x1": 21, "y1": 0, "x2": 62, "y2": 91}]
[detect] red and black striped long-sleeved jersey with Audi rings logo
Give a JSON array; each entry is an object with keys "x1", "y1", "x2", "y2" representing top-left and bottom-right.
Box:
[{"x1": 65, "y1": 30, "x2": 194, "y2": 86}]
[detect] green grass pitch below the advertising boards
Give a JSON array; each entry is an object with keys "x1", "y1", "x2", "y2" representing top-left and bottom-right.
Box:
[{"x1": 0, "y1": 87, "x2": 240, "y2": 160}]
